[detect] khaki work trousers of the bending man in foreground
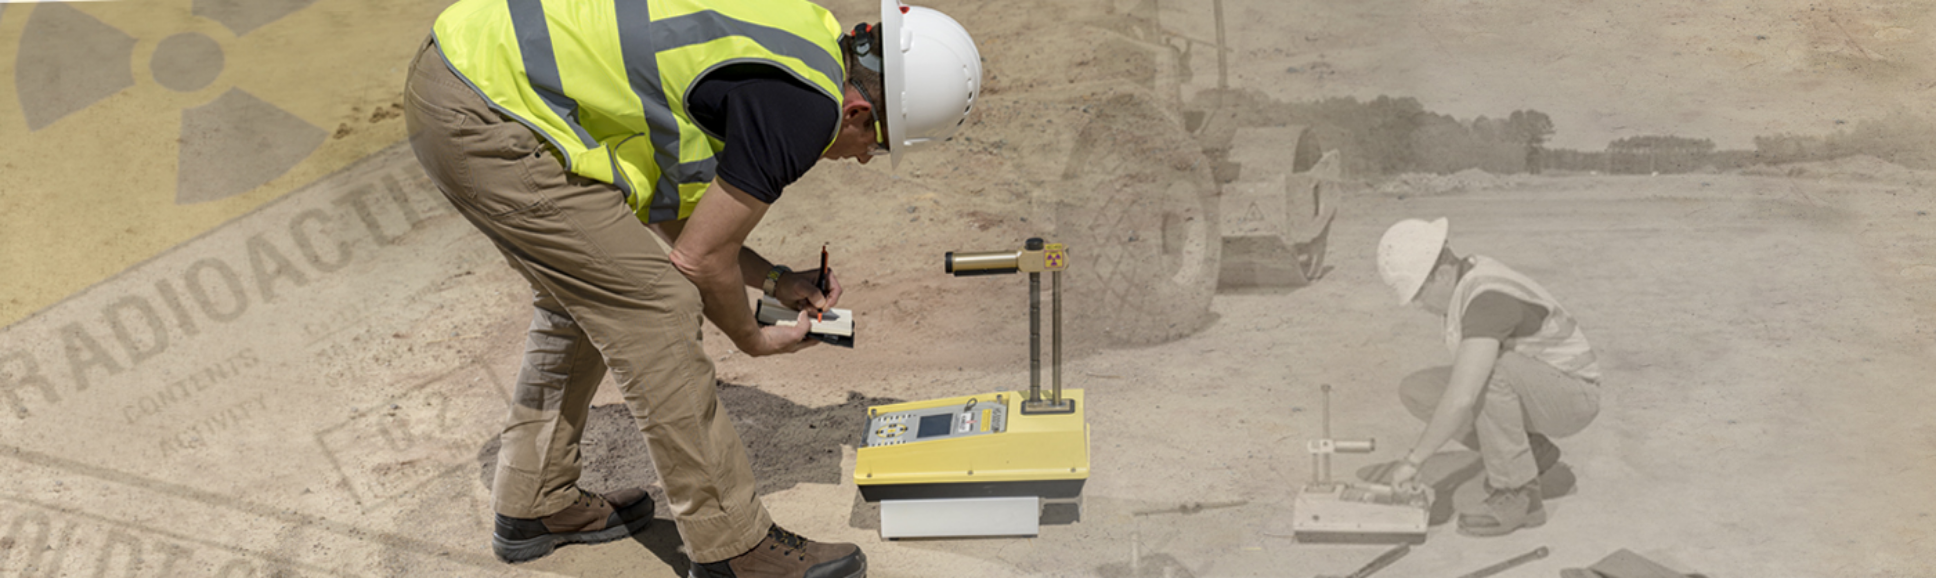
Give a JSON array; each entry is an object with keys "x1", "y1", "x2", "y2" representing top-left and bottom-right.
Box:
[{"x1": 405, "y1": 43, "x2": 772, "y2": 563}]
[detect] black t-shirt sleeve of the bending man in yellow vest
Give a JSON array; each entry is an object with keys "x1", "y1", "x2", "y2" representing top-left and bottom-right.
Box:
[{"x1": 685, "y1": 64, "x2": 840, "y2": 205}]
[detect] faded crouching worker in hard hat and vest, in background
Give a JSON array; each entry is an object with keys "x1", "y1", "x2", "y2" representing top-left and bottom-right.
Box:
[{"x1": 1371, "y1": 218, "x2": 1599, "y2": 535}]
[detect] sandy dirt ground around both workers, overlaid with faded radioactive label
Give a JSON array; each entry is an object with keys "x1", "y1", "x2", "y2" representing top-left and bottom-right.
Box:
[{"x1": 0, "y1": 0, "x2": 1936, "y2": 578}]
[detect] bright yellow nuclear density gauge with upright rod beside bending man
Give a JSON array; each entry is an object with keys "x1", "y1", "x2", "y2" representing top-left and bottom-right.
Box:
[{"x1": 854, "y1": 240, "x2": 1090, "y2": 537}]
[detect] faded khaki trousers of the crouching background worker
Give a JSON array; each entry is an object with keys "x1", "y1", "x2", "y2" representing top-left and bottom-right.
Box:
[{"x1": 1398, "y1": 352, "x2": 1599, "y2": 487}]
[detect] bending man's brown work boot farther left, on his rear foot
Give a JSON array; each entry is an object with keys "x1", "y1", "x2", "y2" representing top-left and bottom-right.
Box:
[{"x1": 490, "y1": 487, "x2": 652, "y2": 563}]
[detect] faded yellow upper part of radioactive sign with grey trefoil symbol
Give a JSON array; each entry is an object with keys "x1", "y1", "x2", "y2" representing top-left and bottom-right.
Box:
[{"x1": 0, "y1": 0, "x2": 443, "y2": 327}]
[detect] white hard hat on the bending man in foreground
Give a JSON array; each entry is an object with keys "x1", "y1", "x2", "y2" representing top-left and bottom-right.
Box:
[{"x1": 881, "y1": 0, "x2": 982, "y2": 164}]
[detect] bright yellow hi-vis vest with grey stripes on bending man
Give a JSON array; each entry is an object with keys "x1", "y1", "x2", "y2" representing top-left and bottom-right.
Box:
[{"x1": 434, "y1": 0, "x2": 846, "y2": 222}]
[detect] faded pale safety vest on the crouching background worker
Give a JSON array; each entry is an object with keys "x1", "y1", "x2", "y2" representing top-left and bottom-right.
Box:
[{"x1": 1446, "y1": 257, "x2": 1599, "y2": 383}]
